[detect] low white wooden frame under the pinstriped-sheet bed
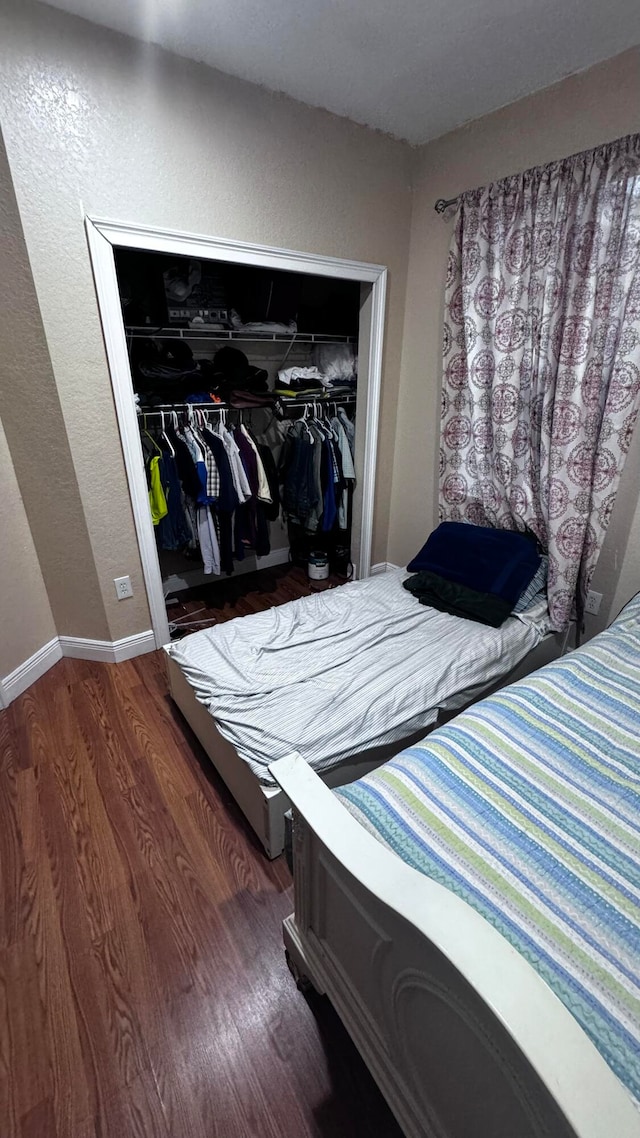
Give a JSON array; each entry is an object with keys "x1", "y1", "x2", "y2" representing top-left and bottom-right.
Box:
[{"x1": 165, "y1": 635, "x2": 561, "y2": 858}]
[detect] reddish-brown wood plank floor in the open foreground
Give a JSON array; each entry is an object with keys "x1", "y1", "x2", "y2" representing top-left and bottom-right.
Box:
[{"x1": 0, "y1": 653, "x2": 400, "y2": 1138}]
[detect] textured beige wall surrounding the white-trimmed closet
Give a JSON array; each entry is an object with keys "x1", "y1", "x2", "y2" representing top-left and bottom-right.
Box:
[{"x1": 0, "y1": 0, "x2": 415, "y2": 638}]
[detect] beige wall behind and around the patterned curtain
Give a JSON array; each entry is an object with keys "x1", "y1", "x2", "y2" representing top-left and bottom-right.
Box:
[{"x1": 388, "y1": 49, "x2": 640, "y2": 632}]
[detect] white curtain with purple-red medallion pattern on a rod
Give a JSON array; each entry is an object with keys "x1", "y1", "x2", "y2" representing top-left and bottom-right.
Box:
[{"x1": 441, "y1": 134, "x2": 640, "y2": 629}]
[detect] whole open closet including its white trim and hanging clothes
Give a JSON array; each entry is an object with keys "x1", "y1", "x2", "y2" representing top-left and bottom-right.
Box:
[{"x1": 88, "y1": 222, "x2": 385, "y2": 643}]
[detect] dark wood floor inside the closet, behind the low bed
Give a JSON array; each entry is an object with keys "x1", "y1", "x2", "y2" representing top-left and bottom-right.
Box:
[{"x1": 161, "y1": 566, "x2": 345, "y2": 634}]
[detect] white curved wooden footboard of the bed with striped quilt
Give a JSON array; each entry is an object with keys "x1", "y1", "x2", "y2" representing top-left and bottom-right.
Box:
[{"x1": 270, "y1": 754, "x2": 640, "y2": 1138}]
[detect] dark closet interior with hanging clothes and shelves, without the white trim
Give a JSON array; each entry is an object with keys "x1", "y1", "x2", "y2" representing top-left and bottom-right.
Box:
[{"x1": 114, "y1": 248, "x2": 361, "y2": 632}]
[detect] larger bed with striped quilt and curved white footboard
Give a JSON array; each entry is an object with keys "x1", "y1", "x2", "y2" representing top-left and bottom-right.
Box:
[{"x1": 272, "y1": 597, "x2": 640, "y2": 1138}]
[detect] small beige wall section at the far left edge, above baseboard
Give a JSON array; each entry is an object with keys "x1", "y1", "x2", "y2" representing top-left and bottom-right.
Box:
[{"x1": 0, "y1": 423, "x2": 56, "y2": 679}]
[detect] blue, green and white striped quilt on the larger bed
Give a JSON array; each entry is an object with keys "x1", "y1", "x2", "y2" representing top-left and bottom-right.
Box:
[{"x1": 336, "y1": 599, "x2": 640, "y2": 1105}]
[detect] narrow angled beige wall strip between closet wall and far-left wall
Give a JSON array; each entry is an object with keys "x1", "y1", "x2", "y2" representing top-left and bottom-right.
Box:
[{"x1": 0, "y1": 124, "x2": 108, "y2": 659}]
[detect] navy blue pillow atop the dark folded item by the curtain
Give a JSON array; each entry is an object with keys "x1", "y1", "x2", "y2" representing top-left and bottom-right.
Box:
[{"x1": 407, "y1": 521, "x2": 540, "y2": 604}]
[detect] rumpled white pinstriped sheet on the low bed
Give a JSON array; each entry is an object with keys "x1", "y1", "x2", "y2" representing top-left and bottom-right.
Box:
[{"x1": 167, "y1": 569, "x2": 549, "y2": 785}]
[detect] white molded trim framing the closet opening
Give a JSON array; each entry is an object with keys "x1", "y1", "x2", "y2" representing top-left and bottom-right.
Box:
[{"x1": 85, "y1": 216, "x2": 387, "y2": 648}]
